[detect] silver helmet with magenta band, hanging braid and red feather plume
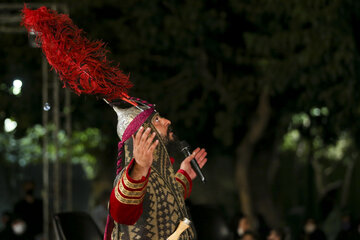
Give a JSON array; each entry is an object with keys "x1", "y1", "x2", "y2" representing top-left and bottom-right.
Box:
[{"x1": 21, "y1": 5, "x2": 155, "y2": 172}]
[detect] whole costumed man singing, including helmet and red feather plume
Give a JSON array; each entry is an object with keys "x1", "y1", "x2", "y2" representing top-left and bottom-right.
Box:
[{"x1": 22, "y1": 6, "x2": 207, "y2": 240}]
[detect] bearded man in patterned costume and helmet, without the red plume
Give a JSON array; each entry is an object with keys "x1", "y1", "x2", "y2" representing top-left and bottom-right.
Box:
[{"x1": 109, "y1": 102, "x2": 207, "y2": 239}]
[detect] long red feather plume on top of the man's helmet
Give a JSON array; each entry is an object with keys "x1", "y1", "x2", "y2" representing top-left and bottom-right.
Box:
[{"x1": 21, "y1": 6, "x2": 133, "y2": 101}]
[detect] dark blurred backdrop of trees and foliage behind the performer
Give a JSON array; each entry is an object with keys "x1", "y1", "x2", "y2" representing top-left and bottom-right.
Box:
[{"x1": 0, "y1": 0, "x2": 360, "y2": 239}]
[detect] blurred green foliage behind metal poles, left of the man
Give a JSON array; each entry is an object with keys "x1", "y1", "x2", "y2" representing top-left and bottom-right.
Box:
[{"x1": 0, "y1": 125, "x2": 103, "y2": 179}]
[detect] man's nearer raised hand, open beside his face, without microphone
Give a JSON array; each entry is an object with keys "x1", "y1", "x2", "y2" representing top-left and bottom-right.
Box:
[{"x1": 130, "y1": 127, "x2": 159, "y2": 180}]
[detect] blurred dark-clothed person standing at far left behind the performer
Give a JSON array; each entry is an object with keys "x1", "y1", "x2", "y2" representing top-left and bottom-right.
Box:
[{"x1": 12, "y1": 181, "x2": 43, "y2": 240}]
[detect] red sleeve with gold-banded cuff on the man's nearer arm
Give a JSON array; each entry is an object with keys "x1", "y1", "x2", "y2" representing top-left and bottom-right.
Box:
[{"x1": 109, "y1": 159, "x2": 150, "y2": 225}]
